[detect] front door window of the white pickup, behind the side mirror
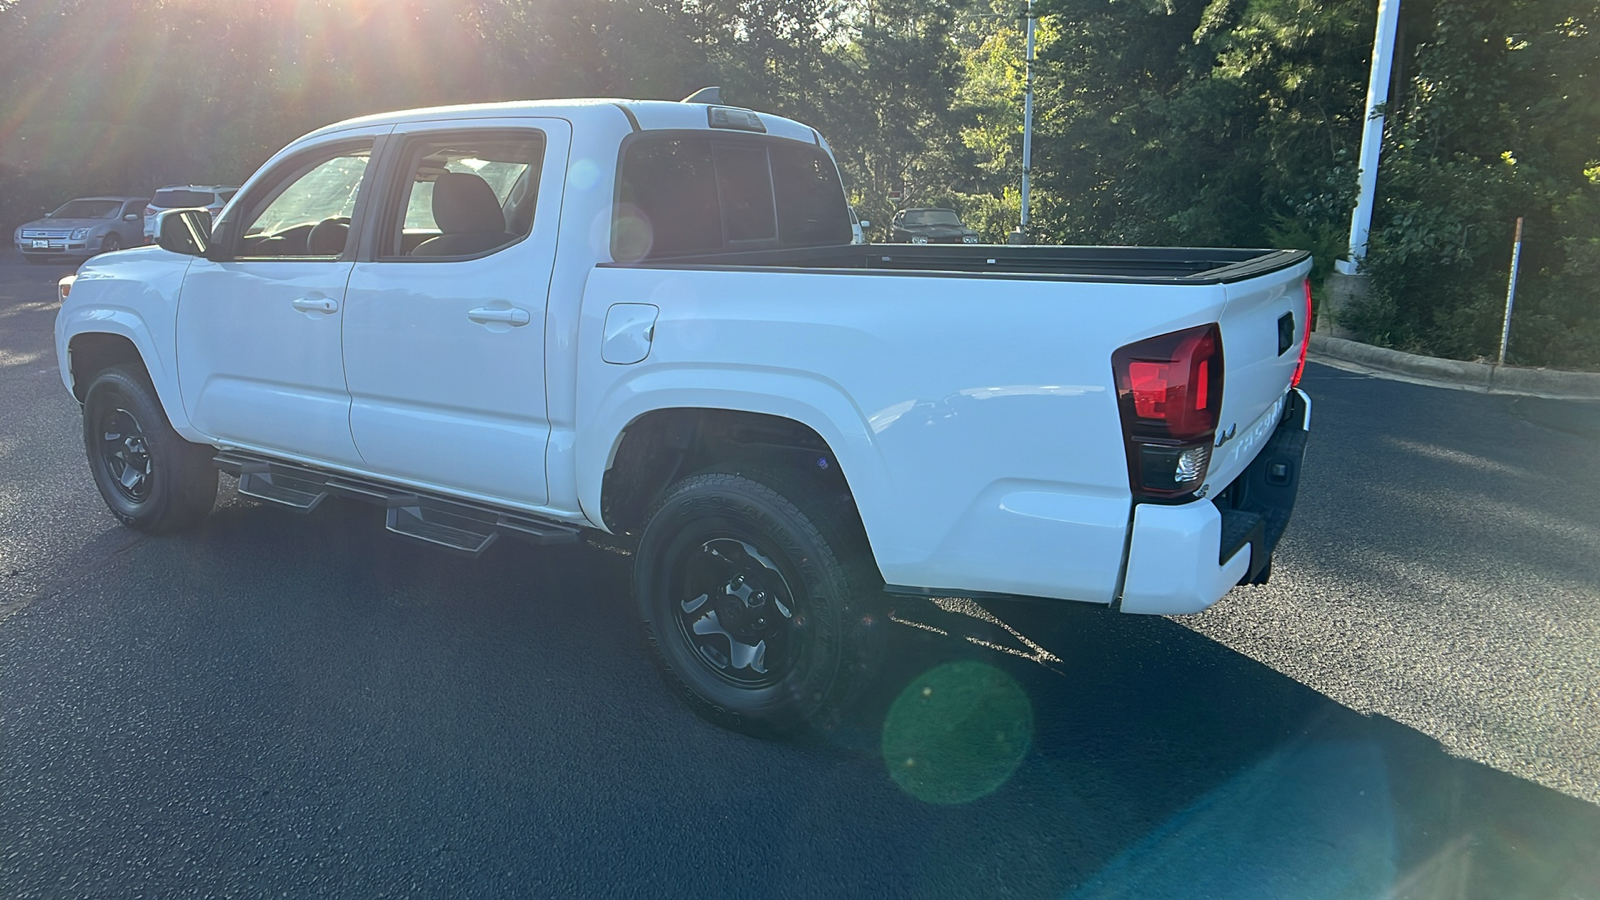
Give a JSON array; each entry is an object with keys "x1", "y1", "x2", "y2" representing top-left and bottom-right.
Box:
[{"x1": 235, "y1": 144, "x2": 371, "y2": 259}]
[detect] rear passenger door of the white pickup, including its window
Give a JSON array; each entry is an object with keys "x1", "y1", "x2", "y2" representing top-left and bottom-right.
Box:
[{"x1": 344, "y1": 119, "x2": 571, "y2": 506}]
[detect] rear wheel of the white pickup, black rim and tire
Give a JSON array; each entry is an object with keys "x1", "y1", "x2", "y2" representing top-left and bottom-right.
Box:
[{"x1": 634, "y1": 471, "x2": 883, "y2": 737}]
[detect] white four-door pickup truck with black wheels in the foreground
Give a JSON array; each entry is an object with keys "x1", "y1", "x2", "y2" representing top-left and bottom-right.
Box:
[{"x1": 56, "y1": 94, "x2": 1310, "y2": 732}]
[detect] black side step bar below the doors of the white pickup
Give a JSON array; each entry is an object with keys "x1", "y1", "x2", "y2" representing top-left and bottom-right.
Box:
[{"x1": 213, "y1": 450, "x2": 579, "y2": 556}]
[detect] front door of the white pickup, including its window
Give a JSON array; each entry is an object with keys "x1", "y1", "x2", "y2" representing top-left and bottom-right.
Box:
[{"x1": 178, "y1": 138, "x2": 387, "y2": 466}]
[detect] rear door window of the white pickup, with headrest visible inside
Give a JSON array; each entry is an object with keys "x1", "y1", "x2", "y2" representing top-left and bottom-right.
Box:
[{"x1": 382, "y1": 131, "x2": 544, "y2": 259}]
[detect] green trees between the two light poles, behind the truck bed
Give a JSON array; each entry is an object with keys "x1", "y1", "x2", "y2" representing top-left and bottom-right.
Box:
[{"x1": 1035, "y1": 0, "x2": 1371, "y2": 250}]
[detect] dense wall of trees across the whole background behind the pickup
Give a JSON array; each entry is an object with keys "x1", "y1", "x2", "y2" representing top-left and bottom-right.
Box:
[{"x1": 0, "y1": 0, "x2": 1600, "y2": 367}]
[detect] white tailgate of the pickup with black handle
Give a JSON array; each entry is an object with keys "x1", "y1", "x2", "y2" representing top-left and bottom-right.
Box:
[{"x1": 1208, "y1": 259, "x2": 1310, "y2": 493}]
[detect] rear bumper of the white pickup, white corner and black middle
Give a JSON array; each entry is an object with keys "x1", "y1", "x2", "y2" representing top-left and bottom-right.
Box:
[{"x1": 1120, "y1": 388, "x2": 1310, "y2": 615}]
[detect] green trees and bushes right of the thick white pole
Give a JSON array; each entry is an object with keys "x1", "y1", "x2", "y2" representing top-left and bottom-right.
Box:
[{"x1": 1350, "y1": 0, "x2": 1600, "y2": 367}]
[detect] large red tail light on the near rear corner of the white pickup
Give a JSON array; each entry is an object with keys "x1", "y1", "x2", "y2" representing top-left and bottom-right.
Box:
[{"x1": 1110, "y1": 325, "x2": 1222, "y2": 500}]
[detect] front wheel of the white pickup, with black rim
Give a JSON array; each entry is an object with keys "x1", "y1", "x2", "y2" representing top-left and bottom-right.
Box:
[{"x1": 83, "y1": 365, "x2": 216, "y2": 535}]
